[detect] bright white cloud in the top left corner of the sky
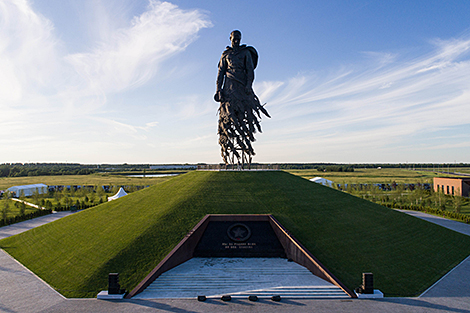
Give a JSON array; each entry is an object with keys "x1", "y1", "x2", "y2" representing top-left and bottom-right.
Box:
[{"x1": 0, "y1": 0, "x2": 60, "y2": 103}]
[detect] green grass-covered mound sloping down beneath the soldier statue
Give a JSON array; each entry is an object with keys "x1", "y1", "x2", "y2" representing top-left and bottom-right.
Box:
[{"x1": 0, "y1": 172, "x2": 470, "y2": 297}]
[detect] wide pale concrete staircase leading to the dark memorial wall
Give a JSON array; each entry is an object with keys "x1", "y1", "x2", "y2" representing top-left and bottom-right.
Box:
[{"x1": 133, "y1": 258, "x2": 349, "y2": 299}]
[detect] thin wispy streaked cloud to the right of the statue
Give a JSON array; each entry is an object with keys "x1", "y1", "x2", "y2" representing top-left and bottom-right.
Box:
[{"x1": 256, "y1": 37, "x2": 470, "y2": 162}]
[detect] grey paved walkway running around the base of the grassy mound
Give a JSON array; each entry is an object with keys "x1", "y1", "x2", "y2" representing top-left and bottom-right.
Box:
[{"x1": 0, "y1": 211, "x2": 470, "y2": 313}]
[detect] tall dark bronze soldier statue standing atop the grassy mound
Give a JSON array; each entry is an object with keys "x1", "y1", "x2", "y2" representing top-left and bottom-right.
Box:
[{"x1": 214, "y1": 30, "x2": 270, "y2": 167}]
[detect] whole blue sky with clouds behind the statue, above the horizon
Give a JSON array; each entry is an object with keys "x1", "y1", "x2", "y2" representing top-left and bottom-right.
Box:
[{"x1": 0, "y1": 0, "x2": 470, "y2": 164}]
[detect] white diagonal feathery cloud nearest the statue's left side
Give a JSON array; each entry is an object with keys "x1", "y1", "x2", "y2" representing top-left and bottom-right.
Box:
[{"x1": 66, "y1": 0, "x2": 211, "y2": 93}]
